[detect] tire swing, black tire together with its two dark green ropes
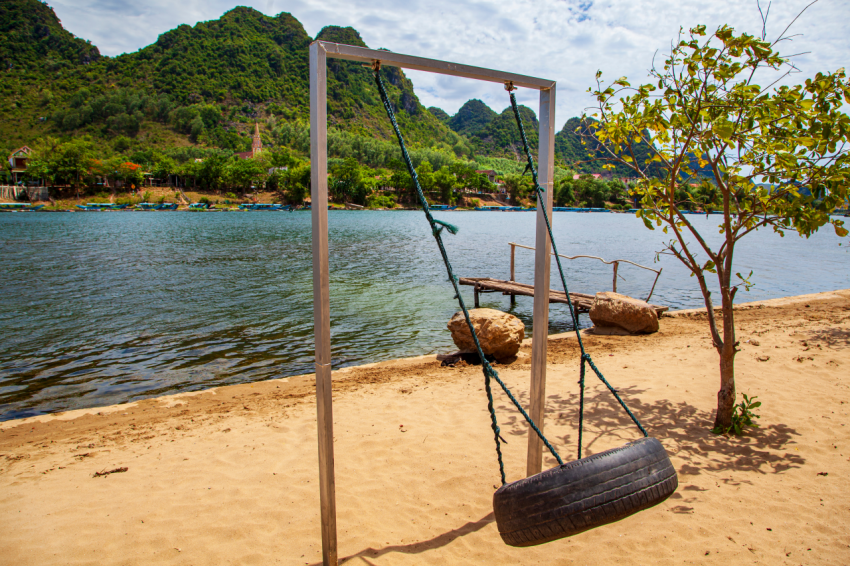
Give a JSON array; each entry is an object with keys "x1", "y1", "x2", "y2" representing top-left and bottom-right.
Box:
[{"x1": 373, "y1": 66, "x2": 678, "y2": 547}]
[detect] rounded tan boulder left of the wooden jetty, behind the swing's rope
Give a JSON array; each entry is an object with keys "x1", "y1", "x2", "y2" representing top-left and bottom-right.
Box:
[{"x1": 448, "y1": 309, "x2": 525, "y2": 360}]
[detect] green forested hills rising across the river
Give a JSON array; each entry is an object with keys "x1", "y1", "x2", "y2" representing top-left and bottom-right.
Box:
[{"x1": 0, "y1": 0, "x2": 664, "y2": 201}]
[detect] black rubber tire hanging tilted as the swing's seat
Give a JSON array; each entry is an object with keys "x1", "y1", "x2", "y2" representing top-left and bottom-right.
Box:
[{"x1": 493, "y1": 438, "x2": 679, "y2": 546}]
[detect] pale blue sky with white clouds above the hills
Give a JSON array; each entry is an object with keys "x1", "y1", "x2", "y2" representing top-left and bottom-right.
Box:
[{"x1": 48, "y1": 0, "x2": 850, "y2": 128}]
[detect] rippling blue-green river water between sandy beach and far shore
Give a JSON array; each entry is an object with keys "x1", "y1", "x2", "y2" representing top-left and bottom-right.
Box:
[{"x1": 0, "y1": 211, "x2": 850, "y2": 420}]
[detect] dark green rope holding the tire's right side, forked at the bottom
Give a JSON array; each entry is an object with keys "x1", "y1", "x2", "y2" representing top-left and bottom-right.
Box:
[{"x1": 505, "y1": 89, "x2": 649, "y2": 460}]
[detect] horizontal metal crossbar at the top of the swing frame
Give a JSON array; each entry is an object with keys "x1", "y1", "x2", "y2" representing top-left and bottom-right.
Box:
[{"x1": 315, "y1": 41, "x2": 555, "y2": 90}]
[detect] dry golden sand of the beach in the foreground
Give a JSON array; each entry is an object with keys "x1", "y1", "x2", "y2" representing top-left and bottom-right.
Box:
[{"x1": 0, "y1": 291, "x2": 850, "y2": 566}]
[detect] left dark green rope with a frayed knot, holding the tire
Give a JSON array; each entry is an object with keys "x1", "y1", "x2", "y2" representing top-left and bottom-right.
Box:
[{"x1": 375, "y1": 64, "x2": 564, "y2": 485}]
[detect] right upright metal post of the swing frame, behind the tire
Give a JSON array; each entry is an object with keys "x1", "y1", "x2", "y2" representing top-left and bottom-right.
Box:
[{"x1": 526, "y1": 85, "x2": 555, "y2": 476}]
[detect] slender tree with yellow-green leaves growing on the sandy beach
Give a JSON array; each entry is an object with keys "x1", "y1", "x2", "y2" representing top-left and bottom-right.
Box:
[{"x1": 593, "y1": 22, "x2": 850, "y2": 431}]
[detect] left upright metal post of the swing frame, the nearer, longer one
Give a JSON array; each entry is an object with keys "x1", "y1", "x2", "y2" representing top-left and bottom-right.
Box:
[{"x1": 310, "y1": 43, "x2": 337, "y2": 566}]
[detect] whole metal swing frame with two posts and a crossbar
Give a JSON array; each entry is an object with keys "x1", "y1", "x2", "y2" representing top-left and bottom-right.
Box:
[{"x1": 310, "y1": 41, "x2": 555, "y2": 566}]
